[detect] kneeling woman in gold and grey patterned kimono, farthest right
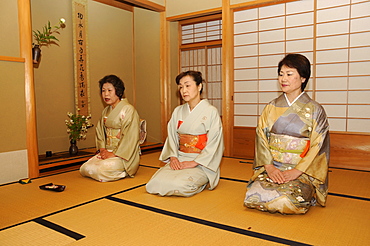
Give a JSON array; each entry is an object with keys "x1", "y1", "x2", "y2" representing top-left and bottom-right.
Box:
[{"x1": 244, "y1": 54, "x2": 329, "y2": 214}]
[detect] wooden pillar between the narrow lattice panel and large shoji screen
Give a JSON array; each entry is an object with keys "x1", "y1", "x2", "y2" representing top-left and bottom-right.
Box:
[{"x1": 222, "y1": 0, "x2": 234, "y2": 156}]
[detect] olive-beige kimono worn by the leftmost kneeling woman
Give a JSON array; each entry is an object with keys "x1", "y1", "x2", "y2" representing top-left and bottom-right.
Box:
[{"x1": 80, "y1": 98, "x2": 140, "y2": 182}]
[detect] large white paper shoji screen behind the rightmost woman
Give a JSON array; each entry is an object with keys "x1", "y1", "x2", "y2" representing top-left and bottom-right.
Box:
[{"x1": 234, "y1": 0, "x2": 370, "y2": 132}]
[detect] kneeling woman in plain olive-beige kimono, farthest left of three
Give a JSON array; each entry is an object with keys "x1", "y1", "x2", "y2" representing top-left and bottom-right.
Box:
[{"x1": 80, "y1": 75, "x2": 140, "y2": 182}]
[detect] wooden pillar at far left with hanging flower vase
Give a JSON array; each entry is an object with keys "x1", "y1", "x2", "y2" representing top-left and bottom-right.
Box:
[{"x1": 18, "y1": 0, "x2": 39, "y2": 178}]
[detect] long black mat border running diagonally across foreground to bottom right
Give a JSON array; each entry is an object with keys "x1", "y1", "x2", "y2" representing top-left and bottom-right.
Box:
[{"x1": 106, "y1": 196, "x2": 310, "y2": 246}]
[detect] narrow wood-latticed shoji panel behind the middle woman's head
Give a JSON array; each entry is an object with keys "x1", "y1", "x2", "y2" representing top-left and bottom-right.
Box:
[{"x1": 180, "y1": 17, "x2": 222, "y2": 115}]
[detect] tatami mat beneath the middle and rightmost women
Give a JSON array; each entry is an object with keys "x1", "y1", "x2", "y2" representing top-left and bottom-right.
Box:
[{"x1": 115, "y1": 175, "x2": 370, "y2": 245}]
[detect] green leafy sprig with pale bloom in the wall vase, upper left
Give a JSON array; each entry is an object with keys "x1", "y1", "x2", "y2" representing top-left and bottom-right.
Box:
[{"x1": 33, "y1": 18, "x2": 66, "y2": 46}]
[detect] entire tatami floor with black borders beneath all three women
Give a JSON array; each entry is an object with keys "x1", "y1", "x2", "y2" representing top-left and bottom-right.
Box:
[{"x1": 0, "y1": 152, "x2": 370, "y2": 245}]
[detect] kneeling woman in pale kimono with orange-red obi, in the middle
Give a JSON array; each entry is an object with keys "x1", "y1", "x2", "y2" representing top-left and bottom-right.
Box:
[{"x1": 146, "y1": 71, "x2": 224, "y2": 197}]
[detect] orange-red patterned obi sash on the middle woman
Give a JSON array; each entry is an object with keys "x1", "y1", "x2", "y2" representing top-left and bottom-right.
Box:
[{"x1": 179, "y1": 134, "x2": 208, "y2": 153}]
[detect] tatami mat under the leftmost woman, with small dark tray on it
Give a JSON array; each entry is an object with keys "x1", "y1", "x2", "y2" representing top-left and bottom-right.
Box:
[{"x1": 0, "y1": 161, "x2": 156, "y2": 228}]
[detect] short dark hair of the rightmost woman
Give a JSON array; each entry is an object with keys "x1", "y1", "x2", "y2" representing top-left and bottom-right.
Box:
[{"x1": 278, "y1": 54, "x2": 311, "y2": 91}]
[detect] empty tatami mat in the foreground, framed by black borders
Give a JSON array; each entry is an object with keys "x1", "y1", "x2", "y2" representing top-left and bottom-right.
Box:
[{"x1": 42, "y1": 199, "x2": 276, "y2": 245}]
